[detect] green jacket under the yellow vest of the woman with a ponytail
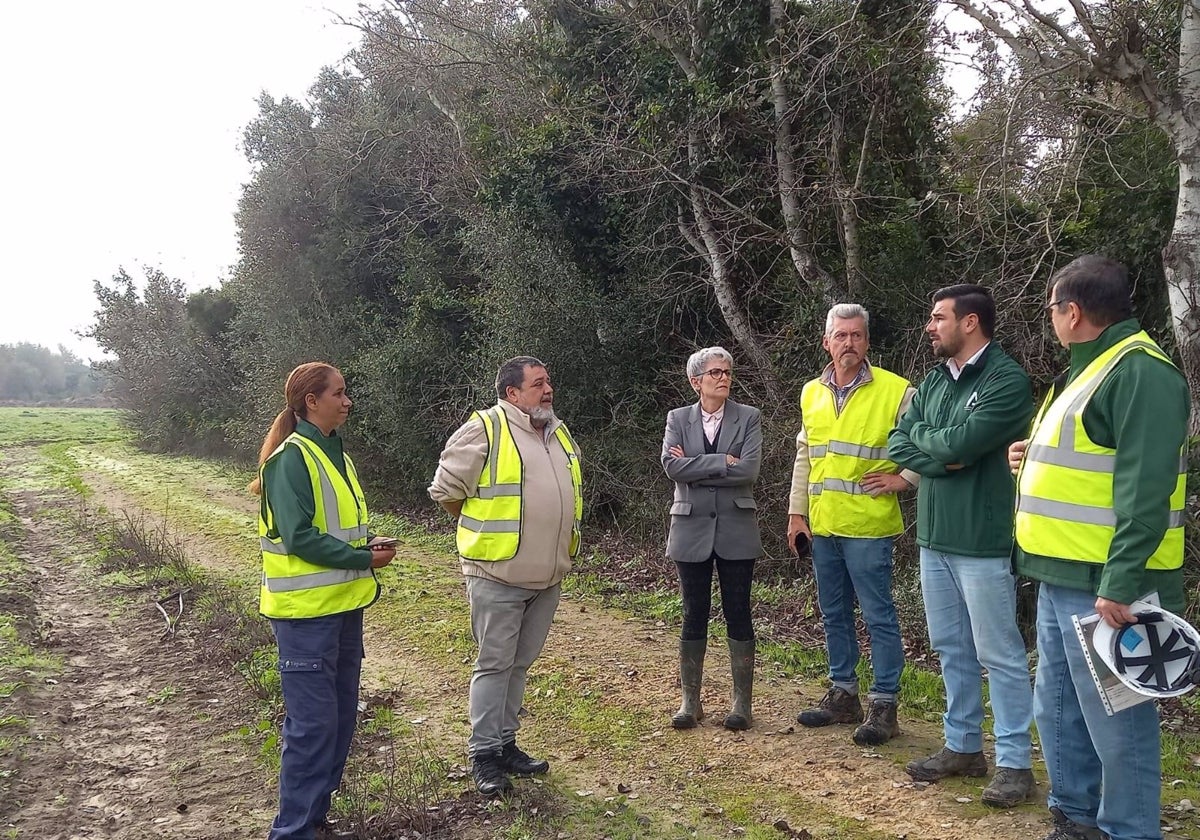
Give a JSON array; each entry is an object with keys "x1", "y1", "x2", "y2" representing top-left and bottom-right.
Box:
[{"x1": 259, "y1": 420, "x2": 371, "y2": 569}]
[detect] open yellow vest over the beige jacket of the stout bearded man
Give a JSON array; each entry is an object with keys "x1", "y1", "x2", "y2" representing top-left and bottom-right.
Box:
[{"x1": 455, "y1": 406, "x2": 583, "y2": 560}]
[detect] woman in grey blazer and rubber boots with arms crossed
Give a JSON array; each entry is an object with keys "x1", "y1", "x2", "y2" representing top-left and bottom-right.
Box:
[{"x1": 662, "y1": 347, "x2": 762, "y2": 730}]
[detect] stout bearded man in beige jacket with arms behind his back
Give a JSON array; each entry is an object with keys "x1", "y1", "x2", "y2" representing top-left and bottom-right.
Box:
[{"x1": 430, "y1": 356, "x2": 583, "y2": 797}]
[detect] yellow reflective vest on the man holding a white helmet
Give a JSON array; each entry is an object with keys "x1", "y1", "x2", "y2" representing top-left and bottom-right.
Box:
[{"x1": 1015, "y1": 331, "x2": 1187, "y2": 569}]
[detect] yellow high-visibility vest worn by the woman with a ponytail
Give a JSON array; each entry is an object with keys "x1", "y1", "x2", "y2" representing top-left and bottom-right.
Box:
[{"x1": 258, "y1": 432, "x2": 379, "y2": 618}]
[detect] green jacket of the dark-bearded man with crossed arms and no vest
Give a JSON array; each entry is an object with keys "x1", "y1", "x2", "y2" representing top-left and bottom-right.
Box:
[{"x1": 888, "y1": 342, "x2": 1033, "y2": 557}]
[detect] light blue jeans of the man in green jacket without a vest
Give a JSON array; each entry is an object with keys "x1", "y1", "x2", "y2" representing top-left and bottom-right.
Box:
[{"x1": 920, "y1": 547, "x2": 1033, "y2": 770}]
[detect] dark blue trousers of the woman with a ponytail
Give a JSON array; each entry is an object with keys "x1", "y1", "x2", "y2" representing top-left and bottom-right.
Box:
[{"x1": 269, "y1": 610, "x2": 362, "y2": 840}]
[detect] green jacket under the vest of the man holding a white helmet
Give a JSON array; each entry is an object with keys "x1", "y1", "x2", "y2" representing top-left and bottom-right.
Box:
[{"x1": 1014, "y1": 318, "x2": 1190, "y2": 612}]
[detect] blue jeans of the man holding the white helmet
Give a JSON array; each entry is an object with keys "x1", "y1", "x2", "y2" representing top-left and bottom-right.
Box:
[{"x1": 1033, "y1": 583, "x2": 1163, "y2": 840}]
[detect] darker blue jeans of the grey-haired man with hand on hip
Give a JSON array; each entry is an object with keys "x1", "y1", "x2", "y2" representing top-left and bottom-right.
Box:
[{"x1": 812, "y1": 536, "x2": 904, "y2": 702}]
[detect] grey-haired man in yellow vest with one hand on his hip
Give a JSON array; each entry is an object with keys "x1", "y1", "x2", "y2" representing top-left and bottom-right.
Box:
[{"x1": 787, "y1": 304, "x2": 918, "y2": 746}]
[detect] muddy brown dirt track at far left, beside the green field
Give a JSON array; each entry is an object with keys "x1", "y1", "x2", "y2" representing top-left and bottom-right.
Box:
[{"x1": 0, "y1": 450, "x2": 274, "y2": 840}]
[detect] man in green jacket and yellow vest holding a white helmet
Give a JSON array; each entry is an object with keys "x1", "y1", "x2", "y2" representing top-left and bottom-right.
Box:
[{"x1": 1009, "y1": 256, "x2": 1190, "y2": 840}]
